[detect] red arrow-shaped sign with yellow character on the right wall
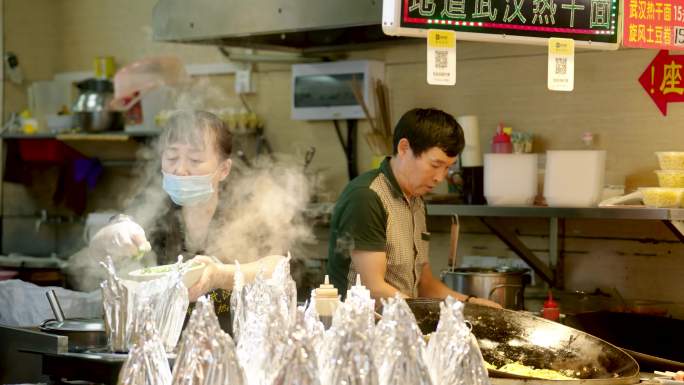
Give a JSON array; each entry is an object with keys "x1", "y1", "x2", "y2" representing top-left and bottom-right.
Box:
[{"x1": 639, "y1": 50, "x2": 684, "y2": 115}]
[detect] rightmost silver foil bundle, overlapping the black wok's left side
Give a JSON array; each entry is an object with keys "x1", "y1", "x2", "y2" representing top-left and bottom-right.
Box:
[{"x1": 425, "y1": 297, "x2": 489, "y2": 385}]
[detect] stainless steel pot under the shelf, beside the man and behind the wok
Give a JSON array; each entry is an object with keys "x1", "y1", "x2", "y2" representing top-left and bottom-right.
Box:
[{"x1": 440, "y1": 268, "x2": 530, "y2": 310}]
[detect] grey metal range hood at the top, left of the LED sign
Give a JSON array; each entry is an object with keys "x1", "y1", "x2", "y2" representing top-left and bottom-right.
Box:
[{"x1": 152, "y1": 0, "x2": 402, "y2": 54}]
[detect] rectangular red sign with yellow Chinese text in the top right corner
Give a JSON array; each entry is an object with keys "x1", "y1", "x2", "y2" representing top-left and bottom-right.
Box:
[{"x1": 622, "y1": 0, "x2": 684, "y2": 49}]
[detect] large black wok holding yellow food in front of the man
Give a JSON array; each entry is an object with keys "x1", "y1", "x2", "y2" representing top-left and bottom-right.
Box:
[{"x1": 407, "y1": 299, "x2": 639, "y2": 384}]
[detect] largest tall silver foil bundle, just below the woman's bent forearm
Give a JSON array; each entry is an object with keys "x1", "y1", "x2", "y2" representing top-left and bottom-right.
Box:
[{"x1": 233, "y1": 257, "x2": 297, "y2": 385}]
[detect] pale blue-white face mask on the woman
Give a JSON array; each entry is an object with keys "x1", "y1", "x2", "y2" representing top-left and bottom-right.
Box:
[{"x1": 162, "y1": 171, "x2": 216, "y2": 206}]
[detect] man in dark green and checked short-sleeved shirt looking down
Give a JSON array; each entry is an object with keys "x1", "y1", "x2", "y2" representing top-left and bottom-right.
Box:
[{"x1": 327, "y1": 109, "x2": 500, "y2": 307}]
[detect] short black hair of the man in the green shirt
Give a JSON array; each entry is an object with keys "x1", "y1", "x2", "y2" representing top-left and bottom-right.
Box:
[{"x1": 393, "y1": 108, "x2": 465, "y2": 157}]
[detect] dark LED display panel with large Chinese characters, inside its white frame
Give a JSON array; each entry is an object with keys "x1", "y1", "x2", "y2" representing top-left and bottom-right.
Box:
[{"x1": 401, "y1": 0, "x2": 620, "y2": 43}]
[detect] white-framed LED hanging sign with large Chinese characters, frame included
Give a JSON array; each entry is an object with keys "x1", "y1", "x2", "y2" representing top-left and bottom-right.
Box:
[{"x1": 382, "y1": 0, "x2": 624, "y2": 49}]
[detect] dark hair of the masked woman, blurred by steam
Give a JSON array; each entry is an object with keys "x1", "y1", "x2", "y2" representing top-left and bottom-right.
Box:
[{"x1": 159, "y1": 110, "x2": 233, "y2": 159}]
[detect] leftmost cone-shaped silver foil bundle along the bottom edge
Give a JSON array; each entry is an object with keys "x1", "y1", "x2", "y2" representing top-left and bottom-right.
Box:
[{"x1": 118, "y1": 306, "x2": 171, "y2": 385}]
